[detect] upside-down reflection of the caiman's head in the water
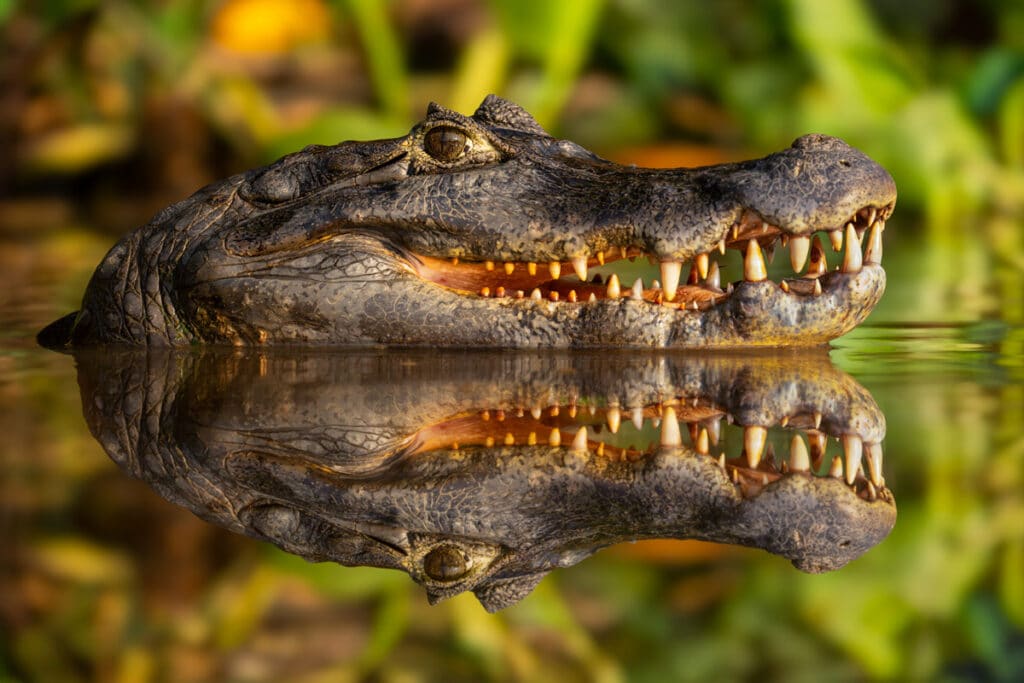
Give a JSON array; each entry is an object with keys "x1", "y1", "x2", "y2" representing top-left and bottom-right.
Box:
[{"x1": 78, "y1": 351, "x2": 896, "y2": 610}]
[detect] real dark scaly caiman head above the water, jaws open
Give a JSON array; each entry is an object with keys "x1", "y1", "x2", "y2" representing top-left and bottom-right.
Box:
[{"x1": 40, "y1": 96, "x2": 896, "y2": 347}]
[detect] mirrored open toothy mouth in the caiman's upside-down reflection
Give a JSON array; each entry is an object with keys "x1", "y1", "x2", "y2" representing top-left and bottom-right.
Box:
[{"x1": 402, "y1": 397, "x2": 893, "y2": 503}]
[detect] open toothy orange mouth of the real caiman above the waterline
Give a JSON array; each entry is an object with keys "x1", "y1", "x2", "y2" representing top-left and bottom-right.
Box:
[{"x1": 412, "y1": 204, "x2": 893, "y2": 310}]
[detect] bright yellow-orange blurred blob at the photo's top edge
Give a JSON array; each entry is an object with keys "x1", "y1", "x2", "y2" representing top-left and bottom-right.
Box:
[{"x1": 210, "y1": 0, "x2": 331, "y2": 54}]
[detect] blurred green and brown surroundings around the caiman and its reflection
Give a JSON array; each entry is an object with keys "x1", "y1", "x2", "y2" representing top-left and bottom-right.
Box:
[{"x1": 0, "y1": 0, "x2": 1024, "y2": 682}]
